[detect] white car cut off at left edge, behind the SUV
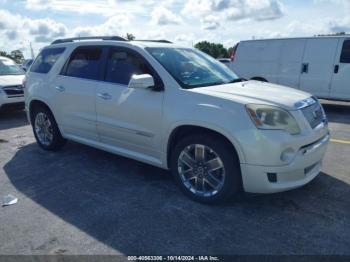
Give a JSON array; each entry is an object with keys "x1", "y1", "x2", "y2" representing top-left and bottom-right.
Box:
[{"x1": 0, "y1": 56, "x2": 24, "y2": 109}]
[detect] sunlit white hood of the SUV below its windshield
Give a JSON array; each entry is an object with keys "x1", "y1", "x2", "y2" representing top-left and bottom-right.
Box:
[{"x1": 192, "y1": 80, "x2": 311, "y2": 110}]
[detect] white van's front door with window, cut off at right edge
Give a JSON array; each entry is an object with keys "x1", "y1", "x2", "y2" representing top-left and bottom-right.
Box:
[{"x1": 330, "y1": 38, "x2": 350, "y2": 100}]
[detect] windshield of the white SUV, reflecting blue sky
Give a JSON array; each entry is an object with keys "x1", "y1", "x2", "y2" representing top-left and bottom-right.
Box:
[{"x1": 146, "y1": 47, "x2": 238, "y2": 89}]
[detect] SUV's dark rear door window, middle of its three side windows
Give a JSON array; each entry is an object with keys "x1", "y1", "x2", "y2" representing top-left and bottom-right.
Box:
[{"x1": 63, "y1": 47, "x2": 102, "y2": 80}]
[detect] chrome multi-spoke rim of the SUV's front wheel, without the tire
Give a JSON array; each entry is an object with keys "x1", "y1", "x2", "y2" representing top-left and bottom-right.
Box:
[{"x1": 178, "y1": 144, "x2": 225, "y2": 197}]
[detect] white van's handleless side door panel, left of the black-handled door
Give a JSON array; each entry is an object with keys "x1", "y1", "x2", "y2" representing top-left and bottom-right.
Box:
[{"x1": 277, "y1": 39, "x2": 306, "y2": 88}]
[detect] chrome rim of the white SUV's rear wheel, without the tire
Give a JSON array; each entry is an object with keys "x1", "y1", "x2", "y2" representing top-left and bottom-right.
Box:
[{"x1": 34, "y1": 112, "x2": 53, "y2": 146}]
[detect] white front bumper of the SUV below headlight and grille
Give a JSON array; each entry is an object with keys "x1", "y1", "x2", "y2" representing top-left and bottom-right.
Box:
[{"x1": 241, "y1": 134, "x2": 330, "y2": 193}]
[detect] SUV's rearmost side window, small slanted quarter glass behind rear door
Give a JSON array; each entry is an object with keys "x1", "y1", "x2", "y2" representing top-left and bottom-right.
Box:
[{"x1": 30, "y1": 48, "x2": 65, "y2": 74}]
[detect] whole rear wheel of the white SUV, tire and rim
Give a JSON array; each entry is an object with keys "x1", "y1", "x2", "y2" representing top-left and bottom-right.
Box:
[{"x1": 31, "y1": 106, "x2": 66, "y2": 151}]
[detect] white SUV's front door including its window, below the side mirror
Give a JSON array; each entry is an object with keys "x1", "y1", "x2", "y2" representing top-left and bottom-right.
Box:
[{"x1": 96, "y1": 47, "x2": 164, "y2": 159}]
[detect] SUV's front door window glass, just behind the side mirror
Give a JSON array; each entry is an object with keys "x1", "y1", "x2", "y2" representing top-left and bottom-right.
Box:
[{"x1": 105, "y1": 49, "x2": 152, "y2": 85}]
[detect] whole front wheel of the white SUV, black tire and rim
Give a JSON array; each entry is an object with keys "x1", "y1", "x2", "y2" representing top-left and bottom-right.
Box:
[{"x1": 171, "y1": 134, "x2": 241, "y2": 203}]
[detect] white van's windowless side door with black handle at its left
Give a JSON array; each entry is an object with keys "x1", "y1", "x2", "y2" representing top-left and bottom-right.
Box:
[{"x1": 300, "y1": 38, "x2": 339, "y2": 98}]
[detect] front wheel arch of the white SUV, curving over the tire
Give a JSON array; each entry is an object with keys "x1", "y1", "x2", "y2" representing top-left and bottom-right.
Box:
[{"x1": 166, "y1": 124, "x2": 244, "y2": 167}]
